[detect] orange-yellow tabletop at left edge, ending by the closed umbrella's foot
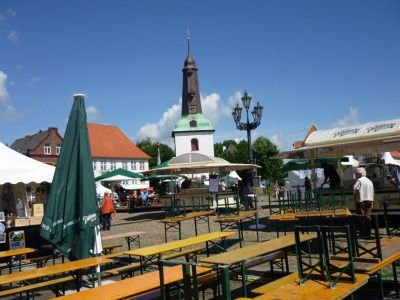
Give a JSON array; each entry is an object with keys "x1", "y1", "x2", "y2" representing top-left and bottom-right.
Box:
[{"x1": 0, "y1": 256, "x2": 112, "y2": 285}]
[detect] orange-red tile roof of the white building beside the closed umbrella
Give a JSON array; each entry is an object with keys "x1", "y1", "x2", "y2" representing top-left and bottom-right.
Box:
[{"x1": 88, "y1": 124, "x2": 150, "y2": 159}]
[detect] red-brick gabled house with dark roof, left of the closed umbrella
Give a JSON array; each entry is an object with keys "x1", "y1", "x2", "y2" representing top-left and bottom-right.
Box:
[{"x1": 10, "y1": 127, "x2": 63, "y2": 166}]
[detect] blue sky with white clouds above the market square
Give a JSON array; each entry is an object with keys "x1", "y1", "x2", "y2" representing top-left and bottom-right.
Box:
[{"x1": 0, "y1": 0, "x2": 400, "y2": 150}]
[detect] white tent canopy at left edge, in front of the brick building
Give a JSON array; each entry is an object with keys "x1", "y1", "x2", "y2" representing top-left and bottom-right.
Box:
[{"x1": 0, "y1": 142, "x2": 55, "y2": 184}]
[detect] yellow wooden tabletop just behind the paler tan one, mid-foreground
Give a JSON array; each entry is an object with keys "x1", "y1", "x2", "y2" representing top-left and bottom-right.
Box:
[{"x1": 125, "y1": 231, "x2": 235, "y2": 256}]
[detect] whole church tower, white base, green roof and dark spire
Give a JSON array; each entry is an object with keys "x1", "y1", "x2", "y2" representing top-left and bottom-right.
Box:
[{"x1": 172, "y1": 36, "x2": 215, "y2": 156}]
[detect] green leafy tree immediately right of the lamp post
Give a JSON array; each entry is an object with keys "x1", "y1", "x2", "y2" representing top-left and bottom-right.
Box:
[{"x1": 252, "y1": 136, "x2": 285, "y2": 184}]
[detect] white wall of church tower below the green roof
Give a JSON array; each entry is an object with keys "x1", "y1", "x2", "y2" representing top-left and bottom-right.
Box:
[{"x1": 174, "y1": 131, "x2": 214, "y2": 156}]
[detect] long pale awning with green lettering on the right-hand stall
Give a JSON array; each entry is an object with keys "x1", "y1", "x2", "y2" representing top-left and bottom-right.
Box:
[{"x1": 273, "y1": 119, "x2": 400, "y2": 159}]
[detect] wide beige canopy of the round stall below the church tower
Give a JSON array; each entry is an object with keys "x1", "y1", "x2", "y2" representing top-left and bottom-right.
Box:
[{"x1": 143, "y1": 152, "x2": 258, "y2": 174}]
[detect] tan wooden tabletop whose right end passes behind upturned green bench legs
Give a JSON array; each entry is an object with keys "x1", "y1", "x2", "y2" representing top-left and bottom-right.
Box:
[{"x1": 200, "y1": 233, "x2": 317, "y2": 265}]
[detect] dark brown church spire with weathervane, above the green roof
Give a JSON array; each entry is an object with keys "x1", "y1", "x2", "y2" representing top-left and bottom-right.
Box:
[{"x1": 182, "y1": 27, "x2": 202, "y2": 117}]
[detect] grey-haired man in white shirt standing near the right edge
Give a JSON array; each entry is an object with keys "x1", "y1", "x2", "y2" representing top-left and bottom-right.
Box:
[{"x1": 353, "y1": 168, "x2": 374, "y2": 238}]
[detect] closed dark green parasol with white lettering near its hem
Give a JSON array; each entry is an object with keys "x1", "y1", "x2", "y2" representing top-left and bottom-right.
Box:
[{"x1": 40, "y1": 95, "x2": 102, "y2": 260}]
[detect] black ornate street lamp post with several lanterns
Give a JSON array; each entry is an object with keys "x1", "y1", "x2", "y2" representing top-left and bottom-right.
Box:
[{"x1": 232, "y1": 90, "x2": 263, "y2": 186}]
